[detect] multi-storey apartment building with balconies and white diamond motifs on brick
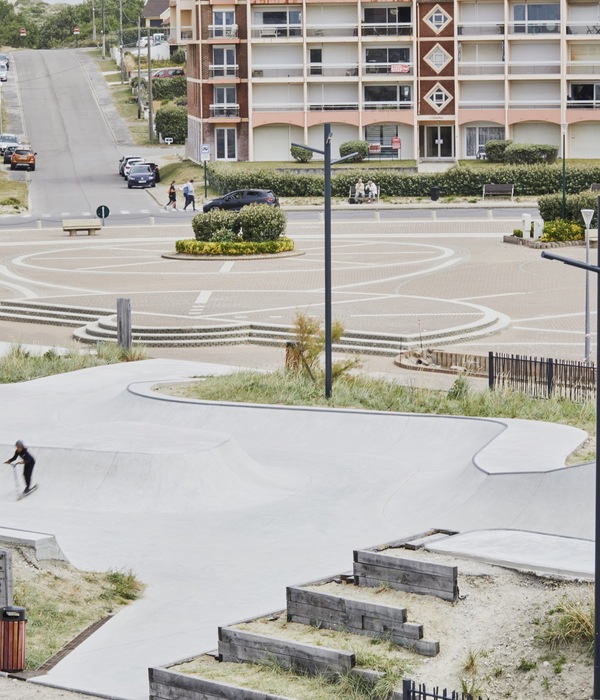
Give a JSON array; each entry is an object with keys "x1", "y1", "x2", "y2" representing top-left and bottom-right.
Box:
[{"x1": 179, "y1": 0, "x2": 600, "y2": 161}]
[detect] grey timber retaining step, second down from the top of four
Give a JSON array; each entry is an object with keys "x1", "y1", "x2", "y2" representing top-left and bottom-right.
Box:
[{"x1": 286, "y1": 586, "x2": 440, "y2": 656}]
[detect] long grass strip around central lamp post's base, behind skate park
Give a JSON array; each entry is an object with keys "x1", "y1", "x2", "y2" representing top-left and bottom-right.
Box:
[{"x1": 158, "y1": 370, "x2": 596, "y2": 452}]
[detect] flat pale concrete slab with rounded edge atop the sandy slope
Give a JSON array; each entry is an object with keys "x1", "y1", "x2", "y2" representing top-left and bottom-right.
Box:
[{"x1": 426, "y1": 529, "x2": 595, "y2": 581}]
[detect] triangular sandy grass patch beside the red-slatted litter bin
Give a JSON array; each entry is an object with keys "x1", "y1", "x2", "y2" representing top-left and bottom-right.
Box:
[{"x1": 13, "y1": 547, "x2": 143, "y2": 671}]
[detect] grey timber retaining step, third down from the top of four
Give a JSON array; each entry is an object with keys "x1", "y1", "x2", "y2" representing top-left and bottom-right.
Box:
[{"x1": 219, "y1": 627, "x2": 356, "y2": 676}]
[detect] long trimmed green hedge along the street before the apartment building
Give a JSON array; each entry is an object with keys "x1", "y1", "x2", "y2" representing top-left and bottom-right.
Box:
[{"x1": 207, "y1": 163, "x2": 600, "y2": 197}]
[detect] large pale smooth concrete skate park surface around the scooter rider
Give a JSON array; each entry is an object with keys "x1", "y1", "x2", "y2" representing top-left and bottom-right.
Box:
[{"x1": 0, "y1": 360, "x2": 594, "y2": 700}]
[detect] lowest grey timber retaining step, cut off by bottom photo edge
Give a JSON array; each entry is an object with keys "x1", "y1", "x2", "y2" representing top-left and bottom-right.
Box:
[{"x1": 148, "y1": 668, "x2": 293, "y2": 700}]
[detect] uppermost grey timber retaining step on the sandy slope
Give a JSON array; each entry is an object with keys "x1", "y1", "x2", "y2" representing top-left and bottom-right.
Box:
[{"x1": 354, "y1": 550, "x2": 458, "y2": 602}]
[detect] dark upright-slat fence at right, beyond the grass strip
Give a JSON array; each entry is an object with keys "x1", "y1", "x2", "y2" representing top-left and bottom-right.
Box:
[{"x1": 488, "y1": 352, "x2": 596, "y2": 401}]
